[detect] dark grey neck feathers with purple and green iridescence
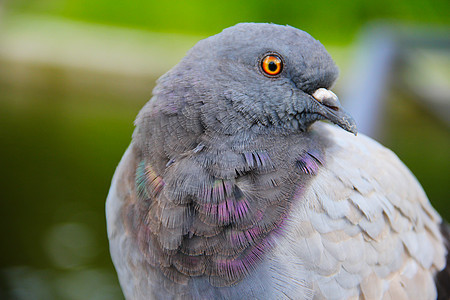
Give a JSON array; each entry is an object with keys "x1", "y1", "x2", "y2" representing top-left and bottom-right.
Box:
[{"x1": 129, "y1": 129, "x2": 323, "y2": 286}]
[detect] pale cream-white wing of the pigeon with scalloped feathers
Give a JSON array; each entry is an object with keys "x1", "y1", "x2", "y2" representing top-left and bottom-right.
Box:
[{"x1": 270, "y1": 123, "x2": 446, "y2": 299}]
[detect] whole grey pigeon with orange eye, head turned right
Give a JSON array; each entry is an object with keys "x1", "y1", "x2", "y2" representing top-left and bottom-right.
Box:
[{"x1": 106, "y1": 23, "x2": 450, "y2": 300}]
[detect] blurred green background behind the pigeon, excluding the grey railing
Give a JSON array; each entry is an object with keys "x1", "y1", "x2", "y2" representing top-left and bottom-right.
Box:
[{"x1": 0, "y1": 0, "x2": 450, "y2": 299}]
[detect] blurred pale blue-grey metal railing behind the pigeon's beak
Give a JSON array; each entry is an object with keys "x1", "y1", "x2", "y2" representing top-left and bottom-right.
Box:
[{"x1": 340, "y1": 23, "x2": 450, "y2": 138}]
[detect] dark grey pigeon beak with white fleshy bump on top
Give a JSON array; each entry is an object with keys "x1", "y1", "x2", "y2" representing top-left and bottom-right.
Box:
[{"x1": 312, "y1": 88, "x2": 357, "y2": 135}]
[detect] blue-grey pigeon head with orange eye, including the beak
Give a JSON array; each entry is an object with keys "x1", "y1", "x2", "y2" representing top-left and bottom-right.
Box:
[{"x1": 147, "y1": 23, "x2": 356, "y2": 134}]
